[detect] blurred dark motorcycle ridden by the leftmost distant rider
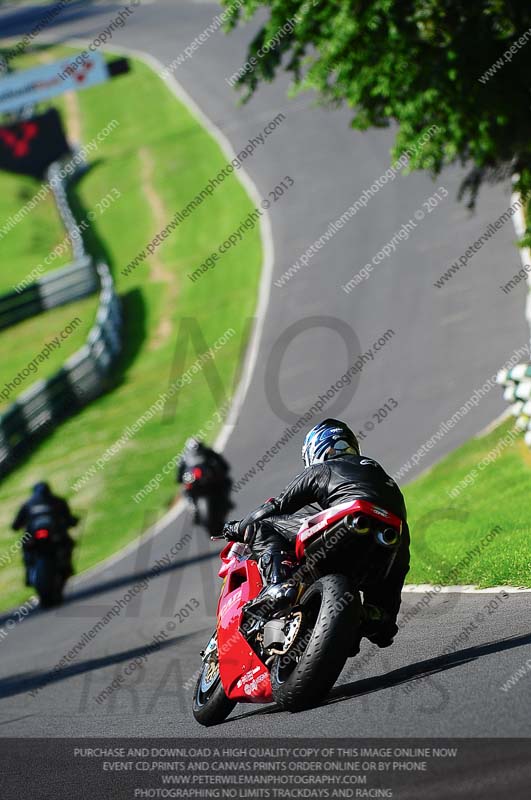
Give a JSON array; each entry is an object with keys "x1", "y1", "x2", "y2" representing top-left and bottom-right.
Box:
[{"x1": 25, "y1": 528, "x2": 68, "y2": 608}]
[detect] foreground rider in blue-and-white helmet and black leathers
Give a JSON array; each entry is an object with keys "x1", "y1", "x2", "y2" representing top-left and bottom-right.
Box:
[{"x1": 224, "y1": 419, "x2": 409, "y2": 655}]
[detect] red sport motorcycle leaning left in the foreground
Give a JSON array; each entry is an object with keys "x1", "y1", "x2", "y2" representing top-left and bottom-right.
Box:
[{"x1": 192, "y1": 500, "x2": 402, "y2": 725}]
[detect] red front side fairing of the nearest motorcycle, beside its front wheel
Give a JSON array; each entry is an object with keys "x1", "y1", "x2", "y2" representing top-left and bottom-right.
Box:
[{"x1": 217, "y1": 560, "x2": 273, "y2": 703}]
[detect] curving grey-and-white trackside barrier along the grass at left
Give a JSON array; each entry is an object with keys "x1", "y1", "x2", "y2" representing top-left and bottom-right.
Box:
[{"x1": 0, "y1": 159, "x2": 122, "y2": 477}]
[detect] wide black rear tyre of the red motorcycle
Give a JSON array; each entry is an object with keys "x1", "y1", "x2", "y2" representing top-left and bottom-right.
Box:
[{"x1": 271, "y1": 575, "x2": 361, "y2": 711}]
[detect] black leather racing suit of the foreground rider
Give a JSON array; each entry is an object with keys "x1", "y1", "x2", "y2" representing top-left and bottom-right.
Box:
[{"x1": 240, "y1": 455, "x2": 409, "y2": 632}]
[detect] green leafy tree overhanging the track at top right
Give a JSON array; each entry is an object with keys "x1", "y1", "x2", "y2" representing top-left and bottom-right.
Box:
[{"x1": 223, "y1": 0, "x2": 531, "y2": 206}]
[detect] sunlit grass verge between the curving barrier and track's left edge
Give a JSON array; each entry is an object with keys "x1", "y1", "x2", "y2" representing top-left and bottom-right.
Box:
[{"x1": 0, "y1": 49, "x2": 261, "y2": 607}]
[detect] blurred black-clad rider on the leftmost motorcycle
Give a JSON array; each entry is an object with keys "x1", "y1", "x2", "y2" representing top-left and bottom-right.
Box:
[{"x1": 11, "y1": 481, "x2": 79, "y2": 586}]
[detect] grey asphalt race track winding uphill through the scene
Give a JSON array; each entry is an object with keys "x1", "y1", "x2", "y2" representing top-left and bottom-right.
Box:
[{"x1": 0, "y1": 0, "x2": 531, "y2": 752}]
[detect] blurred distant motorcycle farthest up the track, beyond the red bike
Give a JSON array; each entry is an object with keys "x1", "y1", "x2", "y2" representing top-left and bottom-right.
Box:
[{"x1": 183, "y1": 466, "x2": 231, "y2": 536}]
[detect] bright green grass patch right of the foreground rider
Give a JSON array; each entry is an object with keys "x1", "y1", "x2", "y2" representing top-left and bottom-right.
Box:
[{"x1": 405, "y1": 421, "x2": 531, "y2": 587}]
